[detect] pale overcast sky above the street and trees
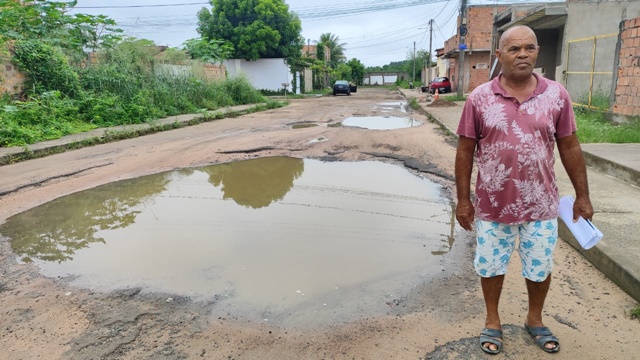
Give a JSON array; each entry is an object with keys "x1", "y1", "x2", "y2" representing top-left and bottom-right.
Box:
[{"x1": 67, "y1": 0, "x2": 558, "y2": 66}]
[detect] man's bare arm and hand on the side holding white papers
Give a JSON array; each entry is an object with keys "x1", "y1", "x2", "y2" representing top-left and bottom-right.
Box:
[{"x1": 557, "y1": 132, "x2": 593, "y2": 221}]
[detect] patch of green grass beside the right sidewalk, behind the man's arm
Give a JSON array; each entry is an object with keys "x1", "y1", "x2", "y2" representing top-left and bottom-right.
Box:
[{"x1": 575, "y1": 107, "x2": 640, "y2": 144}]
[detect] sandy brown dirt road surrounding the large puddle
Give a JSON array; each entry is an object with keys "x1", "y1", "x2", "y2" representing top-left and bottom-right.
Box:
[{"x1": 0, "y1": 89, "x2": 640, "y2": 360}]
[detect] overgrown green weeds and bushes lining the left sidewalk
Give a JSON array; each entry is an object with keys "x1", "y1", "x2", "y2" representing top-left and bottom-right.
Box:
[{"x1": 0, "y1": 40, "x2": 266, "y2": 147}]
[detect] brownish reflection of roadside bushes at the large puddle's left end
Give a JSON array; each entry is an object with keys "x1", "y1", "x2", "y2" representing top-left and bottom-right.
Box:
[{"x1": 0, "y1": 175, "x2": 168, "y2": 262}]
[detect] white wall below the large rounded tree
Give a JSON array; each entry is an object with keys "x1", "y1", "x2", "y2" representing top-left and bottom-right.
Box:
[{"x1": 223, "y1": 59, "x2": 293, "y2": 91}]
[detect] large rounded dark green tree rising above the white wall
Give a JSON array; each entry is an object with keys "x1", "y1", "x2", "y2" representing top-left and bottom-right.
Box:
[{"x1": 197, "y1": 0, "x2": 304, "y2": 60}]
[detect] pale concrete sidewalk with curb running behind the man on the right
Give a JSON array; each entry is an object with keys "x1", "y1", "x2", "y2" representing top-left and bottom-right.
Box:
[{"x1": 405, "y1": 90, "x2": 640, "y2": 301}]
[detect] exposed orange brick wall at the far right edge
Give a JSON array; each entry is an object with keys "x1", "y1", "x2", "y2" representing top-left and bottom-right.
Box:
[{"x1": 612, "y1": 18, "x2": 640, "y2": 116}]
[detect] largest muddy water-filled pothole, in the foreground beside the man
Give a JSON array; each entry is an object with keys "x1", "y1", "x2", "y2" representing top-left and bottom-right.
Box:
[{"x1": 0, "y1": 157, "x2": 453, "y2": 324}]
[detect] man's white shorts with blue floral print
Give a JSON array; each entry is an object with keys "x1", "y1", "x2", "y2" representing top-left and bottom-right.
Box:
[{"x1": 473, "y1": 219, "x2": 558, "y2": 282}]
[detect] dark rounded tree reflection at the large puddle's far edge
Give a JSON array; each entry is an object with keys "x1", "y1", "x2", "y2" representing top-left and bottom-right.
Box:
[{"x1": 204, "y1": 157, "x2": 304, "y2": 209}]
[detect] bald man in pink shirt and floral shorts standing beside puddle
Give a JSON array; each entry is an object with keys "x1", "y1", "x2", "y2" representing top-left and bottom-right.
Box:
[{"x1": 455, "y1": 26, "x2": 593, "y2": 354}]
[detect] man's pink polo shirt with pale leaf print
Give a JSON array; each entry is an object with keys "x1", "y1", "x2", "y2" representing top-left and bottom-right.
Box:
[{"x1": 457, "y1": 73, "x2": 576, "y2": 224}]
